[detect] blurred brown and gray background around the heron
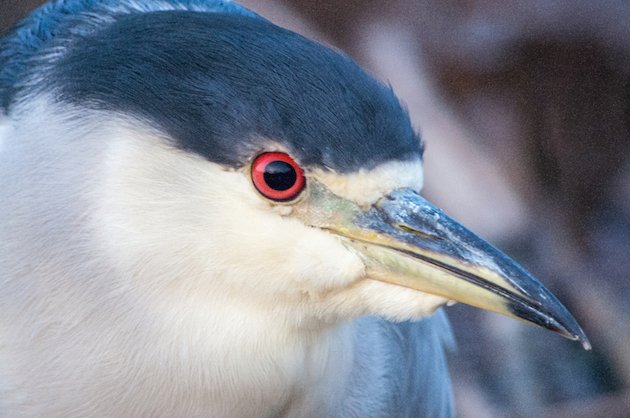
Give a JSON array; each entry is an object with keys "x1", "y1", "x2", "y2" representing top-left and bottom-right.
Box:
[{"x1": 0, "y1": 0, "x2": 630, "y2": 418}]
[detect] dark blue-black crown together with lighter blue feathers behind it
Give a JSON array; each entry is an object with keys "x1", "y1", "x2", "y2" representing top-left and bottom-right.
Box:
[{"x1": 0, "y1": 0, "x2": 422, "y2": 172}]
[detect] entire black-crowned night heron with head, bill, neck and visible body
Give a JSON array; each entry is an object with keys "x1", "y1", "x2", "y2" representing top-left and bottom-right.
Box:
[{"x1": 0, "y1": 0, "x2": 588, "y2": 417}]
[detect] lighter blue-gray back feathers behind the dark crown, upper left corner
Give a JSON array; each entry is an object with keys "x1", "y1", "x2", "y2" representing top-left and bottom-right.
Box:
[{"x1": 0, "y1": 0, "x2": 259, "y2": 110}]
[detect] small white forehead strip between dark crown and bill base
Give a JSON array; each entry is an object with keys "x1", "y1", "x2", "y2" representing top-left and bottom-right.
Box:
[{"x1": 310, "y1": 159, "x2": 424, "y2": 206}]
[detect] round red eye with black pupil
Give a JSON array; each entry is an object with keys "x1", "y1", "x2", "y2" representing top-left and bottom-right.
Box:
[{"x1": 252, "y1": 152, "x2": 306, "y2": 202}]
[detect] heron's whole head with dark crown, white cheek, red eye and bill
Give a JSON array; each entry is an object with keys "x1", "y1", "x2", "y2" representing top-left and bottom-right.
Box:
[{"x1": 3, "y1": 0, "x2": 588, "y2": 347}]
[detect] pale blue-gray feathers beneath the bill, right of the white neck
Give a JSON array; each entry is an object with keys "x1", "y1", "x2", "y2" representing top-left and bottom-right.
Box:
[{"x1": 337, "y1": 310, "x2": 454, "y2": 418}]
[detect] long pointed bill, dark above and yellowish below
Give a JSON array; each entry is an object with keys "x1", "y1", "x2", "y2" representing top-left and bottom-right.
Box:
[{"x1": 298, "y1": 184, "x2": 591, "y2": 350}]
